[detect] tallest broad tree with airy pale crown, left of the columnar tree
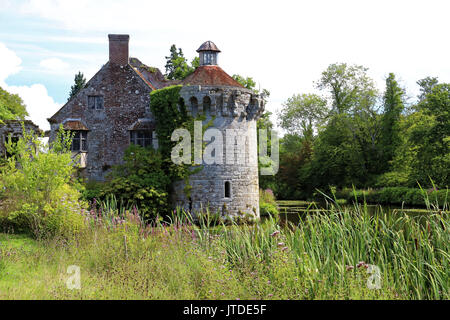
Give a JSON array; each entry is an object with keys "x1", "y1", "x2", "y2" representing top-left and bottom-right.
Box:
[{"x1": 316, "y1": 63, "x2": 381, "y2": 183}]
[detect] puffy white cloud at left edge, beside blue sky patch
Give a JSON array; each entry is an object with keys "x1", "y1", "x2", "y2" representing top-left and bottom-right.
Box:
[{"x1": 0, "y1": 43, "x2": 60, "y2": 130}]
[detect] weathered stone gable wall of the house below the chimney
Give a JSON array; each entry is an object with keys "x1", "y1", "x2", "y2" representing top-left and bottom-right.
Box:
[{"x1": 49, "y1": 63, "x2": 153, "y2": 180}]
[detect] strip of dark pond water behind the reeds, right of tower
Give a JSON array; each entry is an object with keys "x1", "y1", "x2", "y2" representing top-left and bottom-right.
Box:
[{"x1": 277, "y1": 200, "x2": 446, "y2": 225}]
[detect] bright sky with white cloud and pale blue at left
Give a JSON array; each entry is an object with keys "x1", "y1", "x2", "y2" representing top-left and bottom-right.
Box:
[{"x1": 0, "y1": 0, "x2": 450, "y2": 130}]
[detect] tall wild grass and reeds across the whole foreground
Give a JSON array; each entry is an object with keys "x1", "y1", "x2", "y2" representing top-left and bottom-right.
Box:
[{"x1": 0, "y1": 200, "x2": 450, "y2": 300}]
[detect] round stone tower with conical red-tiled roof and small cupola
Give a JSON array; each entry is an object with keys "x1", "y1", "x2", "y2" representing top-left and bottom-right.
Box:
[{"x1": 174, "y1": 41, "x2": 264, "y2": 217}]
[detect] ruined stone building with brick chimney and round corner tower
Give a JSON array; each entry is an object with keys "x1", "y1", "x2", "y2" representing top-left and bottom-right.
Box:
[{"x1": 48, "y1": 35, "x2": 264, "y2": 216}]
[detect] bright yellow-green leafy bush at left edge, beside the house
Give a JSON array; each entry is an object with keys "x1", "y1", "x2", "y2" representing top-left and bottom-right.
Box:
[{"x1": 0, "y1": 125, "x2": 84, "y2": 237}]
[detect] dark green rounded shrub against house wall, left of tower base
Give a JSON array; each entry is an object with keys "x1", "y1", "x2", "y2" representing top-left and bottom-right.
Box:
[{"x1": 100, "y1": 144, "x2": 171, "y2": 220}]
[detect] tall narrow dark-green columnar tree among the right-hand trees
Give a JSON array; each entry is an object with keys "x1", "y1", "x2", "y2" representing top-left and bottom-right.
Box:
[{"x1": 381, "y1": 73, "x2": 405, "y2": 171}]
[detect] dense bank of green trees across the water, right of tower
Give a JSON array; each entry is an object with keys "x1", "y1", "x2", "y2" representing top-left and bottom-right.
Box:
[{"x1": 268, "y1": 63, "x2": 450, "y2": 200}]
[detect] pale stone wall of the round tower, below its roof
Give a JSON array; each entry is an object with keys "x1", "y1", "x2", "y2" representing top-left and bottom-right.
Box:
[{"x1": 173, "y1": 86, "x2": 264, "y2": 217}]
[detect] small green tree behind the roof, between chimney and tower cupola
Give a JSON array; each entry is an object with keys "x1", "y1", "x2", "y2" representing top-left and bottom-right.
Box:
[{"x1": 165, "y1": 44, "x2": 200, "y2": 80}]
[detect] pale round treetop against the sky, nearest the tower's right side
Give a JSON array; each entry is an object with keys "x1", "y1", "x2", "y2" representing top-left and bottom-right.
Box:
[{"x1": 278, "y1": 94, "x2": 328, "y2": 136}]
